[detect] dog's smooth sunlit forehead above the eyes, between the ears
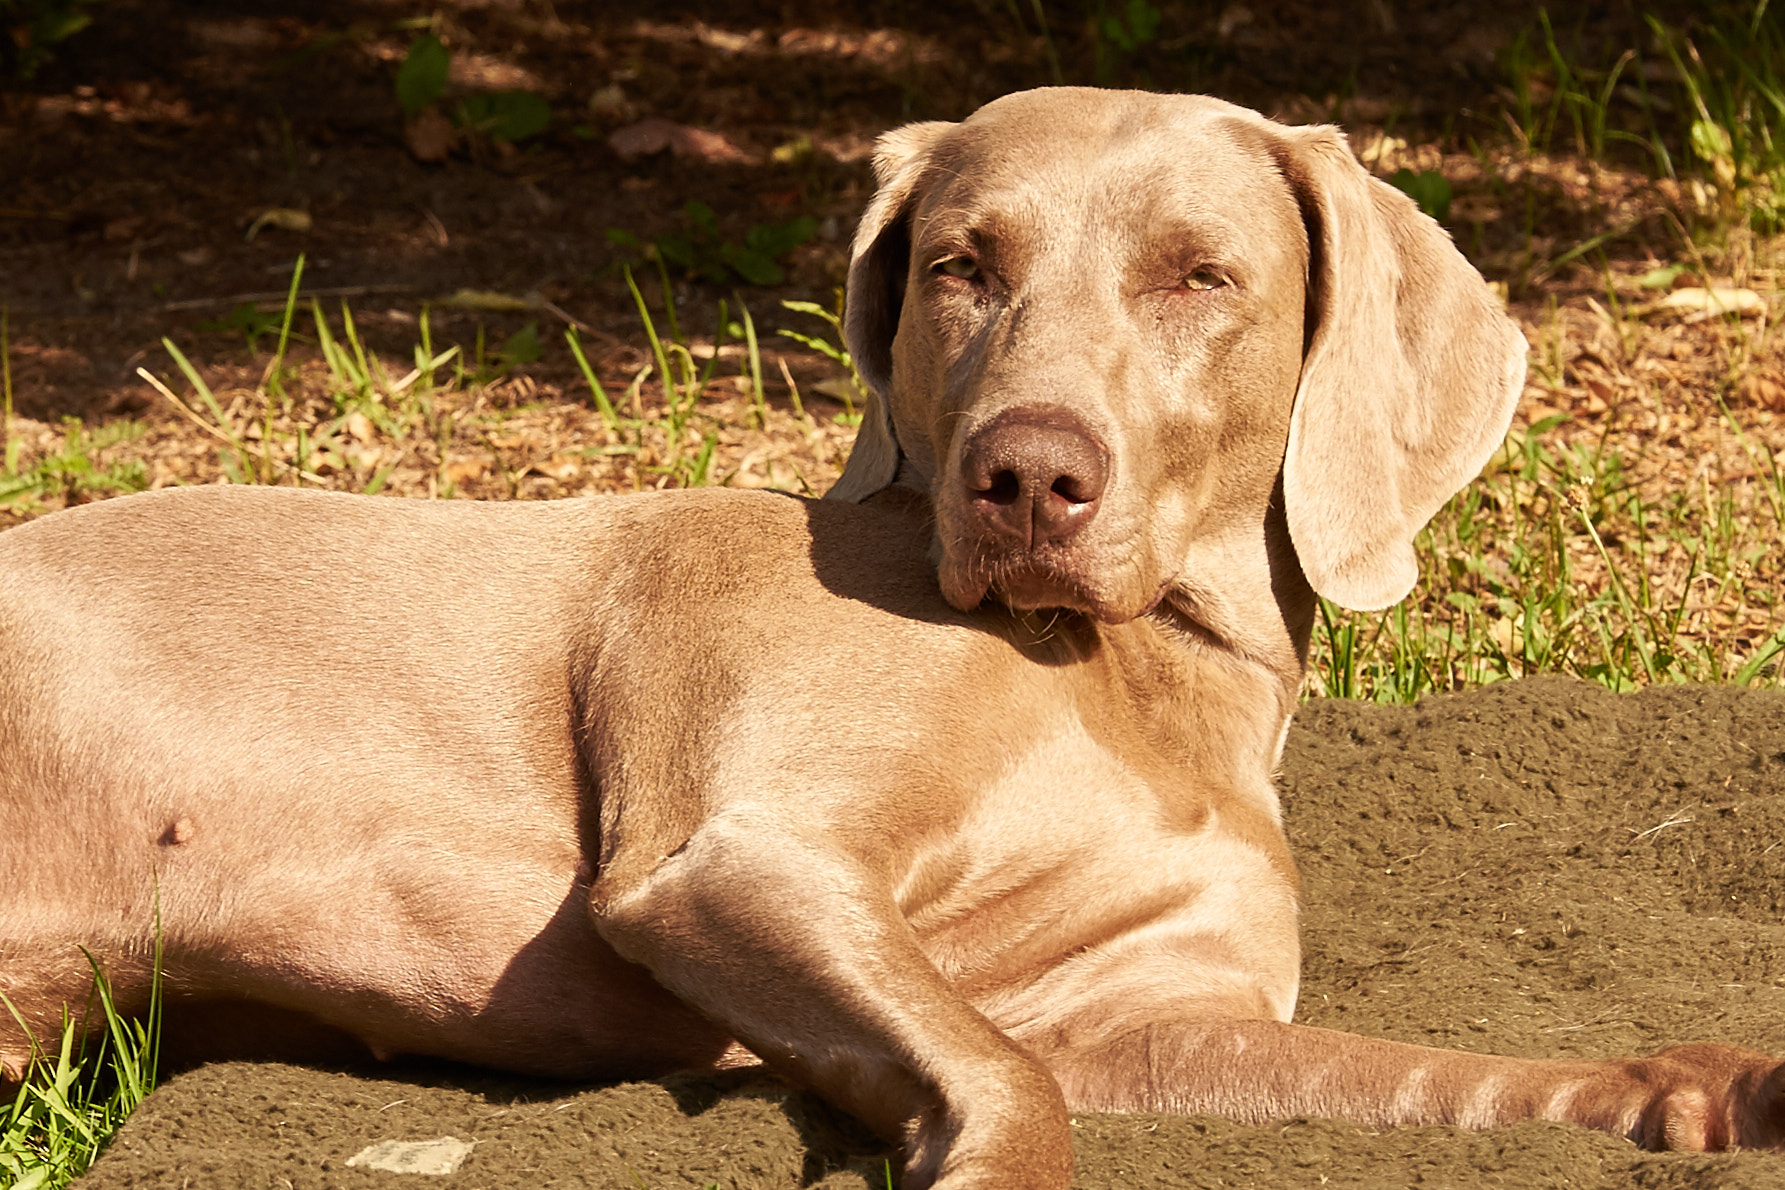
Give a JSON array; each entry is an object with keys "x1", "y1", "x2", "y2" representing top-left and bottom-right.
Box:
[{"x1": 912, "y1": 89, "x2": 1303, "y2": 268}]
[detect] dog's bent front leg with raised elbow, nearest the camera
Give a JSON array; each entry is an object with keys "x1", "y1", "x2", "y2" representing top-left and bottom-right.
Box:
[{"x1": 591, "y1": 814, "x2": 1071, "y2": 1190}]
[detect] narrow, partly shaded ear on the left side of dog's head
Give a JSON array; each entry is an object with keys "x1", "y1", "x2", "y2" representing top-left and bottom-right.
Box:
[{"x1": 825, "y1": 121, "x2": 955, "y2": 503}]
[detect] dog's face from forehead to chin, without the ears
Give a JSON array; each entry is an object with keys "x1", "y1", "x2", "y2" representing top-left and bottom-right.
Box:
[{"x1": 889, "y1": 95, "x2": 1307, "y2": 621}]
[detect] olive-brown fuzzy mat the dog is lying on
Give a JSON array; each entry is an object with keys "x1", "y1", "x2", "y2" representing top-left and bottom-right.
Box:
[{"x1": 80, "y1": 680, "x2": 1785, "y2": 1190}]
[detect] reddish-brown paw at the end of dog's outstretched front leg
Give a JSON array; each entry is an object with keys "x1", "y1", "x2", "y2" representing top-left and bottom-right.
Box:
[{"x1": 1623, "y1": 1044, "x2": 1785, "y2": 1153}]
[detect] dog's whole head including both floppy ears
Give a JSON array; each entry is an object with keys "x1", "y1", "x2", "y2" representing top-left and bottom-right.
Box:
[{"x1": 830, "y1": 87, "x2": 1524, "y2": 623}]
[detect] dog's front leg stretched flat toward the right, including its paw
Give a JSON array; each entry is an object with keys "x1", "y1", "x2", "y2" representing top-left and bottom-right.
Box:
[{"x1": 1041, "y1": 1021, "x2": 1785, "y2": 1151}]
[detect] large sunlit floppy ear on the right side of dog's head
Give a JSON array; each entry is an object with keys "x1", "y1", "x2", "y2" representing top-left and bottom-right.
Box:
[{"x1": 1280, "y1": 127, "x2": 1526, "y2": 610}]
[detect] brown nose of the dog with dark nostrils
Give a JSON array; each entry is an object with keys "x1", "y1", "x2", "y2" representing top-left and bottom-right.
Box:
[{"x1": 960, "y1": 405, "x2": 1108, "y2": 550}]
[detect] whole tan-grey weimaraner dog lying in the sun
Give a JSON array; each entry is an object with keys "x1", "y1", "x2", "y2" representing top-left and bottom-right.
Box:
[{"x1": 0, "y1": 89, "x2": 1785, "y2": 1190}]
